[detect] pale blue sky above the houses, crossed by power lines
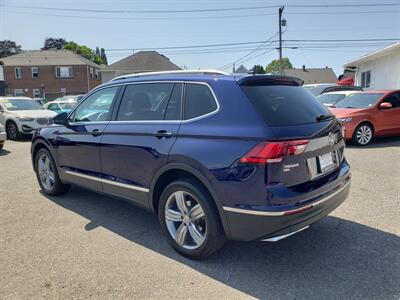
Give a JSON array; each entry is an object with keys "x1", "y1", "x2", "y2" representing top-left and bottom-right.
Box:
[{"x1": 0, "y1": 0, "x2": 400, "y2": 75}]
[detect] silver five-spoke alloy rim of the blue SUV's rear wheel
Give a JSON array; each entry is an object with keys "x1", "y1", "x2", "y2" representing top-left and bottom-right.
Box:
[{"x1": 165, "y1": 191, "x2": 207, "y2": 250}]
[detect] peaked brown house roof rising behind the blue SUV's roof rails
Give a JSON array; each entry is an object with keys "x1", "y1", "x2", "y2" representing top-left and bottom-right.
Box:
[{"x1": 101, "y1": 51, "x2": 181, "y2": 73}]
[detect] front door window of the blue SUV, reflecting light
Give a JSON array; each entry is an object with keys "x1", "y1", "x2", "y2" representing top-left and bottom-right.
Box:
[{"x1": 73, "y1": 86, "x2": 118, "y2": 122}]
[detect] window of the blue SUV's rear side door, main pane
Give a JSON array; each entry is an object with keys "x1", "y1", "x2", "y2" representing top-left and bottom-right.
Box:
[{"x1": 117, "y1": 83, "x2": 174, "y2": 121}]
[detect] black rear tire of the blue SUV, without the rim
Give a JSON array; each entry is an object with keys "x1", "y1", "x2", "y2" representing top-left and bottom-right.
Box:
[{"x1": 158, "y1": 179, "x2": 225, "y2": 259}]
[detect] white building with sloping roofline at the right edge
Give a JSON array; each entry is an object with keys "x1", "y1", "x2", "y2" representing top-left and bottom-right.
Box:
[{"x1": 344, "y1": 42, "x2": 400, "y2": 89}]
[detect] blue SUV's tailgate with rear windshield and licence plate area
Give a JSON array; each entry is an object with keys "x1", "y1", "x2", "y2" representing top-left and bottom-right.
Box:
[{"x1": 242, "y1": 84, "x2": 344, "y2": 187}]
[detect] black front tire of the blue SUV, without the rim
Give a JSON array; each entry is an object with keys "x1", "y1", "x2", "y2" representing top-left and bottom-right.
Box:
[{"x1": 35, "y1": 148, "x2": 70, "y2": 196}]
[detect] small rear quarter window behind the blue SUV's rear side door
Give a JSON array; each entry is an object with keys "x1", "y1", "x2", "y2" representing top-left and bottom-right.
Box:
[{"x1": 185, "y1": 83, "x2": 217, "y2": 120}]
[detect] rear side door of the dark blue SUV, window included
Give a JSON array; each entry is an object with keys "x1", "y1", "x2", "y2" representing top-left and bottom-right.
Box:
[{"x1": 101, "y1": 82, "x2": 182, "y2": 206}]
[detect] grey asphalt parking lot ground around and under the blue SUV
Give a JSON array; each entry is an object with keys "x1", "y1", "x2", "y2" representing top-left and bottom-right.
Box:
[{"x1": 0, "y1": 138, "x2": 400, "y2": 299}]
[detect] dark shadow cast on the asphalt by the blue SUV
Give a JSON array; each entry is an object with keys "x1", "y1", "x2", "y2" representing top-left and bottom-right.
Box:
[{"x1": 42, "y1": 187, "x2": 400, "y2": 299}]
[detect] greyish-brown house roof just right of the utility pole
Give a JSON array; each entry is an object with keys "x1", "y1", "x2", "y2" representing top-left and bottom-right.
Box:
[{"x1": 285, "y1": 67, "x2": 337, "y2": 84}]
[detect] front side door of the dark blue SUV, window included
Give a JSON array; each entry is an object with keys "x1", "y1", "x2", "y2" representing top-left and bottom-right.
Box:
[{"x1": 55, "y1": 86, "x2": 119, "y2": 190}]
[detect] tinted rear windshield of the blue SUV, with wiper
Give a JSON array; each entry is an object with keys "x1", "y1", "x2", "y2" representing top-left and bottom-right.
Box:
[{"x1": 242, "y1": 85, "x2": 331, "y2": 126}]
